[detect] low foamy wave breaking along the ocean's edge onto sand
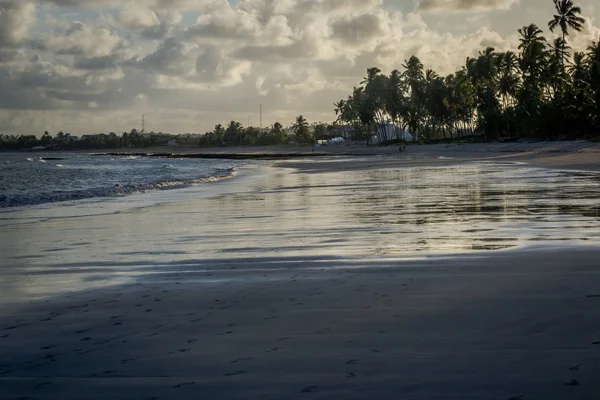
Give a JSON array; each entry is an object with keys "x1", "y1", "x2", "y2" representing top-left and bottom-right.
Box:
[{"x1": 0, "y1": 167, "x2": 235, "y2": 208}]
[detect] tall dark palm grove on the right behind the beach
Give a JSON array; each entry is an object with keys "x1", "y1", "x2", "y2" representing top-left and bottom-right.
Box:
[{"x1": 334, "y1": 0, "x2": 600, "y2": 141}]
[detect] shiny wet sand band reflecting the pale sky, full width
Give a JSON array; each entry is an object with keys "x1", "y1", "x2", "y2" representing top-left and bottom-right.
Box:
[{"x1": 0, "y1": 164, "x2": 600, "y2": 300}]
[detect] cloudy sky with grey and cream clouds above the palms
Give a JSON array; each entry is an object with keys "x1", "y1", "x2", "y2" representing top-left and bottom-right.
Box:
[{"x1": 0, "y1": 0, "x2": 600, "y2": 135}]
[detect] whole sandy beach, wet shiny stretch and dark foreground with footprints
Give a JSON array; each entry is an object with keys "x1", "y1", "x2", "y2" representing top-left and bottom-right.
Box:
[{"x1": 0, "y1": 142, "x2": 600, "y2": 400}]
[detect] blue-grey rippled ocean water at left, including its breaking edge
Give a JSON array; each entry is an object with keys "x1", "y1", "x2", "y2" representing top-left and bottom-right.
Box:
[{"x1": 0, "y1": 152, "x2": 236, "y2": 208}]
